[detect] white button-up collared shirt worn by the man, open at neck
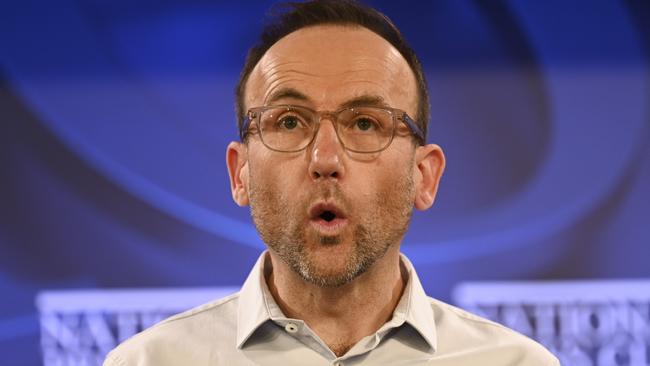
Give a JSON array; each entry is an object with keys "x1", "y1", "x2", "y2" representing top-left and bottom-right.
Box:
[{"x1": 104, "y1": 252, "x2": 560, "y2": 366}]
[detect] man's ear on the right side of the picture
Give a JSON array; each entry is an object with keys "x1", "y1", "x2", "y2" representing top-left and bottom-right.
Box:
[{"x1": 413, "y1": 144, "x2": 445, "y2": 211}]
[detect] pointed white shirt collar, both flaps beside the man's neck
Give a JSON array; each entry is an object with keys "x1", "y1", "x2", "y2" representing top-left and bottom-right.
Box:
[{"x1": 237, "y1": 251, "x2": 437, "y2": 352}]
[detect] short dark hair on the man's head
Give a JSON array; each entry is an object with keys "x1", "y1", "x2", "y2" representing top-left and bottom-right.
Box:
[{"x1": 236, "y1": 0, "x2": 430, "y2": 141}]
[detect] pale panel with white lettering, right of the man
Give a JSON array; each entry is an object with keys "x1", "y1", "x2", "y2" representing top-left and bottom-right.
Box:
[{"x1": 453, "y1": 280, "x2": 650, "y2": 366}]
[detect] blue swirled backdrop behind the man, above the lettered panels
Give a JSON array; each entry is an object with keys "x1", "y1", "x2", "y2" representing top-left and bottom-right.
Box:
[{"x1": 0, "y1": 0, "x2": 650, "y2": 365}]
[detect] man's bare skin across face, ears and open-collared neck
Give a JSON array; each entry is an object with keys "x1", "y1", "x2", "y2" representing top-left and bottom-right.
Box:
[{"x1": 226, "y1": 25, "x2": 445, "y2": 355}]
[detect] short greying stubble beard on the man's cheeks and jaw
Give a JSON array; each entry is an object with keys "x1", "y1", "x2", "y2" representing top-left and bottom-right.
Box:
[{"x1": 249, "y1": 164, "x2": 414, "y2": 287}]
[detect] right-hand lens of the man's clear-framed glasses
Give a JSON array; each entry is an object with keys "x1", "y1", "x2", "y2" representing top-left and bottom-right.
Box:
[{"x1": 339, "y1": 107, "x2": 394, "y2": 152}]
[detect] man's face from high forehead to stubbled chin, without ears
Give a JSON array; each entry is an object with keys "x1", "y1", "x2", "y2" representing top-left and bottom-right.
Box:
[{"x1": 231, "y1": 25, "x2": 432, "y2": 287}]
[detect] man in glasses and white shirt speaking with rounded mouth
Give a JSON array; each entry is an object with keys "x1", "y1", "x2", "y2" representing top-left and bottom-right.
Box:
[{"x1": 106, "y1": 0, "x2": 559, "y2": 366}]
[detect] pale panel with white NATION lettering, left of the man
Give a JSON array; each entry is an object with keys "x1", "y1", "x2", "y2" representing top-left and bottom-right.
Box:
[{"x1": 36, "y1": 287, "x2": 239, "y2": 366}]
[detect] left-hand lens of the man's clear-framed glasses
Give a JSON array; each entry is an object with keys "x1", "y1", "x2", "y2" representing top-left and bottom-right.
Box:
[{"x1": 259, "y1": 106, "x2": 314, "y2": 151}]
